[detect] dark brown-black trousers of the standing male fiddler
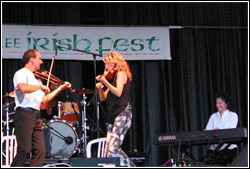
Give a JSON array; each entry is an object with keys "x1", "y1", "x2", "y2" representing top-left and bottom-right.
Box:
[{"x1": 11, "y1": 109, "x2": 46, "y2": 167}]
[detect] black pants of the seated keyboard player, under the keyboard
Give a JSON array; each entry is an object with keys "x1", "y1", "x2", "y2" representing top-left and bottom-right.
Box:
[{"x1": 204, "y1": 148, "x2": 238, "y2": 166}]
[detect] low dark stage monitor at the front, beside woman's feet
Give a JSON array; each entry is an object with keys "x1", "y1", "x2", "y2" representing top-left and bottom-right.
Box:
[{"x1": 70, "y1": 157, "x2": 120, "y2": 167}]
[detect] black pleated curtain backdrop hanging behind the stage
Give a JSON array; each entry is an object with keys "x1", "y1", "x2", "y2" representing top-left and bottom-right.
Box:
[{"x1": 1, "y1": 2, "x2": 249, "y2": 166}]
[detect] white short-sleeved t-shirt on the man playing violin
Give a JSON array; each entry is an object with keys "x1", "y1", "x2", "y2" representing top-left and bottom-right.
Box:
[{"x1": 13, "y1": 68, "x2": 44, "y2": 110}]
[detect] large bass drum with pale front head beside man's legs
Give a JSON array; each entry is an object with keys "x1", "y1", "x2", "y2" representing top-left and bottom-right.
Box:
[{"x1": 43, "y1": 121, "x2": 78, "y2": 159}]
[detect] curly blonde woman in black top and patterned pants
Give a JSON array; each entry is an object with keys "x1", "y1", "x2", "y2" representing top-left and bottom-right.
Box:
[{"x1": 96, "y1": 52, "x2": 135, "y2": 167}]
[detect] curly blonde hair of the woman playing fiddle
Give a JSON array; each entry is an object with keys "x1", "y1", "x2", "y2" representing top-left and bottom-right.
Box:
[{"x1": 103, "y1": 52, "x2": 132, "y2": 81}]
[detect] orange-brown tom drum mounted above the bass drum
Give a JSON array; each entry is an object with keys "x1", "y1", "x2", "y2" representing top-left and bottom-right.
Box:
[{"x1": 60, "y1": 102, "x2": 80, "y2": 123}]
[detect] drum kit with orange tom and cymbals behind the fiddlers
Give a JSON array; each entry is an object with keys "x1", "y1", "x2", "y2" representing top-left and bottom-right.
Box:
[{"x1": 2, "y1": 89, "x2": 100, "y2": 159}]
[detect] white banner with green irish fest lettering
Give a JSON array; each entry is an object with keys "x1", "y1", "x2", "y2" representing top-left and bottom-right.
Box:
[{"x1": 2, "y1": 25, "x2": 171, "y2": 60}]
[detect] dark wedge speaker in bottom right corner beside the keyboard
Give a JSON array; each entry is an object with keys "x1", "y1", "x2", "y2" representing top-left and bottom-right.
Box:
[{"x1": 231, "y1": 146, "x2": 248, "y2": 167}]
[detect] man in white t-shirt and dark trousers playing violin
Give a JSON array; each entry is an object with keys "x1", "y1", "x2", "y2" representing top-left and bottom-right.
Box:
[{"x1": 11, "y1": 49, "x2": 71, "y2": 167}]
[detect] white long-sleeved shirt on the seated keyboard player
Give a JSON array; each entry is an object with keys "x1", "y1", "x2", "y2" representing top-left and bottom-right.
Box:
[{"x1": 206, "y1": 110, "x2": 238, "y2": 150}]
